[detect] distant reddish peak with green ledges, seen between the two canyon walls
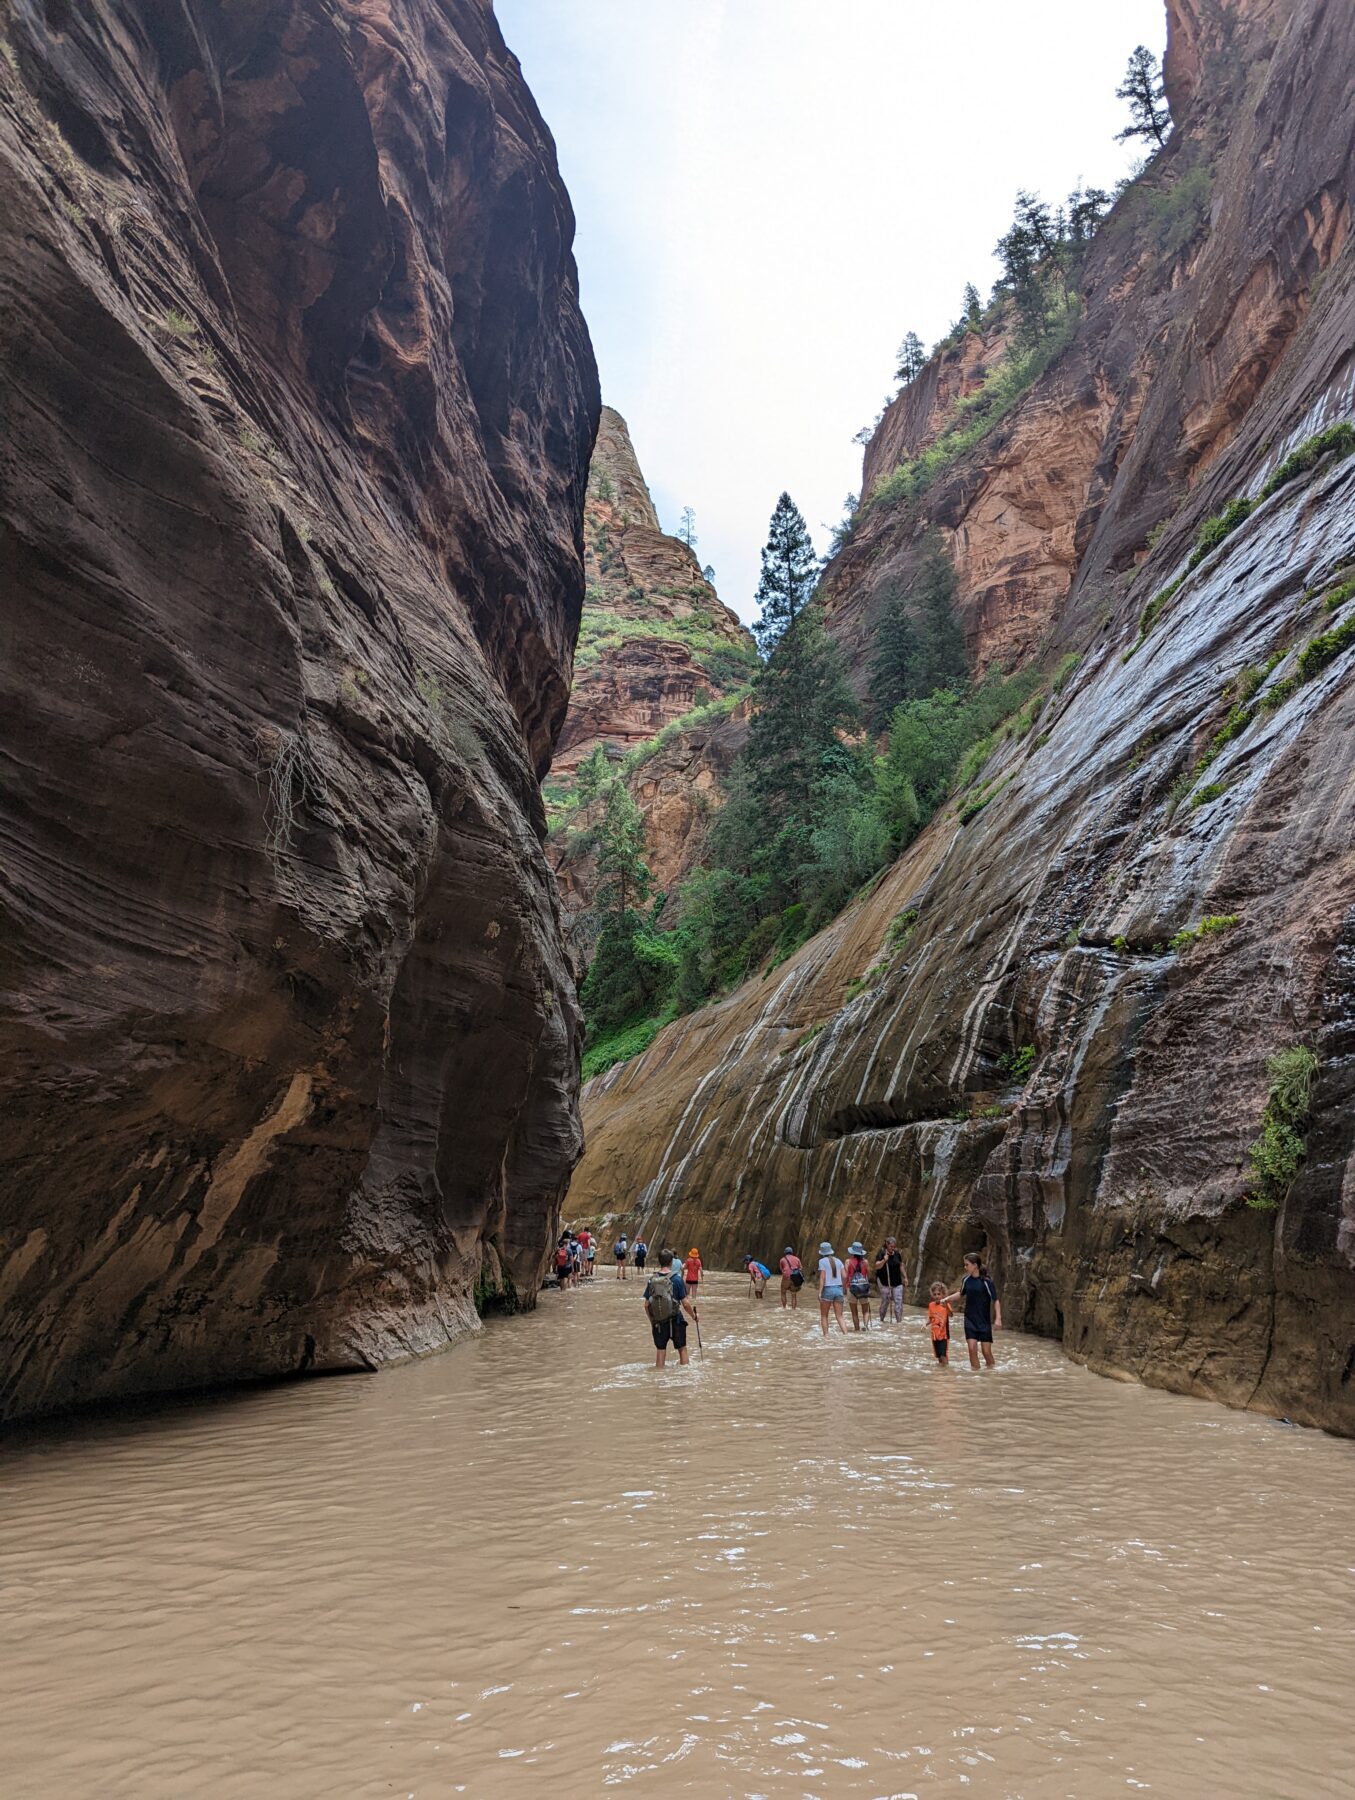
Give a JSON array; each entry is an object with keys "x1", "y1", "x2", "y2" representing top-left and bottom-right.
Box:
[{"x1": 547, "y1": 407, "x2": 756, "y2": 918}]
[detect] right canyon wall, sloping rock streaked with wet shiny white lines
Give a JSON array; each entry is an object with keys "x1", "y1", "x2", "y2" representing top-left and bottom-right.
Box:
[{"x1": 574, "y1": 0, "x2": 1355, "y2": 1433}]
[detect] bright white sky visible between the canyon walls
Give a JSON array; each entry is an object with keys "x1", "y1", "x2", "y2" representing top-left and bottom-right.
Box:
[{"x1": 497, "y1": 0, "x2": 1166, "y2": 617}]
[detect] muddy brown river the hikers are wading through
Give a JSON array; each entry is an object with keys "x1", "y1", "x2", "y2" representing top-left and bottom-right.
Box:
[{"x1": 0, "y1": 1274, "x2": 1355, "y2": 1800}]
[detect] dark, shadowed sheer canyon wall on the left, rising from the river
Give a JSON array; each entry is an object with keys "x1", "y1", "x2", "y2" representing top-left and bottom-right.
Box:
[{"x1": 0, "y1": 0, "x2": 597, "y2": 1415}]
